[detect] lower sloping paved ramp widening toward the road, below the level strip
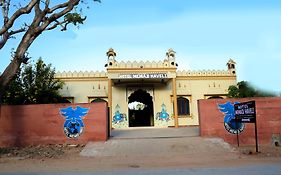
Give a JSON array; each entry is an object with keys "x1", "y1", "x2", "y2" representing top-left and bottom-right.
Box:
[{"x1": 80, "y1": 137, "x2": 234, "y2": 159}]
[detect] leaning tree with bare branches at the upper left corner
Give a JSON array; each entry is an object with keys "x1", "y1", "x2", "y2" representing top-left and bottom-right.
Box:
[{"x1": 0, "y1": 0, "x2": 100, "y2": 102}]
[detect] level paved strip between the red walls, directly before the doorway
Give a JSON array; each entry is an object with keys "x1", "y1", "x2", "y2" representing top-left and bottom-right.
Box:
[{"x1": 110, "y1": 127, "x2": 199, "y2": 139}]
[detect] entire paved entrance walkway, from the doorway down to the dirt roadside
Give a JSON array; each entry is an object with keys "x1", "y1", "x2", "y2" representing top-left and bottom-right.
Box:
[{"x1": 81, "y1": 127, "x2": 237, "y2": 157}]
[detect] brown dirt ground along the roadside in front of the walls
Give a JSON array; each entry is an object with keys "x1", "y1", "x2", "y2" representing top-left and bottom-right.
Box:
[{"x1": 0, "y1": 145, "x2": 281, "y2": 172}]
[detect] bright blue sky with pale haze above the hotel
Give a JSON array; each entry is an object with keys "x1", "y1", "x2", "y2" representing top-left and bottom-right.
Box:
[{"x1": 0, "y1": 0, "x2": 281, "y2": 92}]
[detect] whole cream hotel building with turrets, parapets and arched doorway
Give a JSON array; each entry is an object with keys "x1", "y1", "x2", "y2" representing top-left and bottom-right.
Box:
[{"x1": 56, "y1": 49, "x2": 236, "y2": 128}]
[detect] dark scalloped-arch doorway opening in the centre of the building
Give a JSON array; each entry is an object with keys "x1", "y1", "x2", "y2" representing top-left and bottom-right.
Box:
[{"x1": 128, "y1": 89, "x2": 154, "y2": 127}]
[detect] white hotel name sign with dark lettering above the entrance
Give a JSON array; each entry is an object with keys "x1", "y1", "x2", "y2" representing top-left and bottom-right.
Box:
[{"x1": 118, "y1": 73, "x2": 168, "y2": 79}]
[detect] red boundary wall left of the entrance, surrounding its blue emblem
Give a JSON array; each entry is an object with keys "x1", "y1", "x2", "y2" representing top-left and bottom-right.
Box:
[{"x1": 0, "y1": 103, "x2": 107, "y2": 146}]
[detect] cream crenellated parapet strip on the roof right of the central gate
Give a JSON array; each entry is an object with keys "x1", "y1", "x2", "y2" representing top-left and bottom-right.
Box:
[{"x1": 177, "y1": 70, "x2": 235, "y2": 77}]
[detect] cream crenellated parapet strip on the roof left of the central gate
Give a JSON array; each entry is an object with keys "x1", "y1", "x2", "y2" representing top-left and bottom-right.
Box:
[{"x1": 55, "y1": 71, "x2": 107, "y2": 78}]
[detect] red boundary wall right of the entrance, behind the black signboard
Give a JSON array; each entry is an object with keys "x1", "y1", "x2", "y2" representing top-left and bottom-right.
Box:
[{"x1": 198, "y1": 97, "x2": 281, "y2": 145}]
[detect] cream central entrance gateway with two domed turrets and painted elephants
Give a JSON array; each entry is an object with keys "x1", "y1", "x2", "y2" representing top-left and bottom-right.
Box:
[{"x1": 106, "y1": 49, "x2": 178, "y2": 128}]
